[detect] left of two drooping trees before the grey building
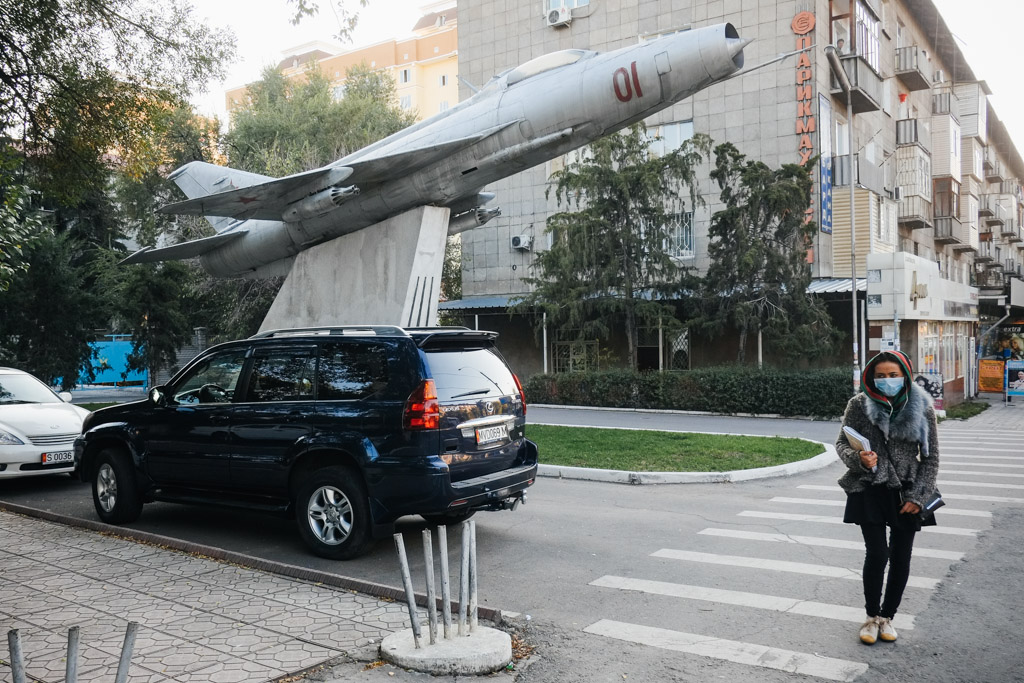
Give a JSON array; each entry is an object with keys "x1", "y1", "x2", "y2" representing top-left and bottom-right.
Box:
[{"x1": 515, "y1": 124, "x2": 710, "y2": 369}]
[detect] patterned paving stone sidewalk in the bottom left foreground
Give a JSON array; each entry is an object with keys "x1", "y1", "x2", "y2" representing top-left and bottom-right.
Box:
[{"x1": 0, "y1": 511, "x2": 409, "y2": 683}]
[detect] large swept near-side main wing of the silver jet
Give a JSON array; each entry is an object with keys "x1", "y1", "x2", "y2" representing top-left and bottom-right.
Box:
[{"x1": 159, "y1": 166, "x2": 352, "y2": 220}]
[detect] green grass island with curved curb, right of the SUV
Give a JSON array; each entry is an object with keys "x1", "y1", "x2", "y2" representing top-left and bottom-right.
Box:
[{"x1": 526, "y1": 425, "x2": 823, "y2": 472}]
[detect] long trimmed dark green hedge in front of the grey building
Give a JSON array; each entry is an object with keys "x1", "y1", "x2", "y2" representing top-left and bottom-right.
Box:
[{"x1": 523, "y1": 367, "x2": 853, "y2": 418}]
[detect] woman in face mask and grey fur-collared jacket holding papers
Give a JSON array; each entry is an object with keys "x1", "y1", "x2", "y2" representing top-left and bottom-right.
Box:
[{"x1": 836, "y1": 351, "x2": 939, "y2": 645}]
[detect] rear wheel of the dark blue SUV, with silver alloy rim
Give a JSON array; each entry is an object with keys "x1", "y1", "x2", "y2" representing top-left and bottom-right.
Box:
[{"x1": 295, "y1": 467, "x2": 370, "y2": 560}]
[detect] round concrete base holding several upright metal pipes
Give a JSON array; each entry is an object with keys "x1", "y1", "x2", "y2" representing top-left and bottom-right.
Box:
[{"x1": 380, "y1": 626, "x2": 512, "y2": 675}]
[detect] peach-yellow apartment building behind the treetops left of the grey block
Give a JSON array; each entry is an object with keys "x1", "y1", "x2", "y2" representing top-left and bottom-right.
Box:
[{"x1": 230, "y1": 0, "x2": 459, "y2": 120}]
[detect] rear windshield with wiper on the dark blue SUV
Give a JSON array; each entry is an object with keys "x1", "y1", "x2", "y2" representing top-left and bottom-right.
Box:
[{"x1": 427, "y1": 347, "x2": 518, "y2": 401}]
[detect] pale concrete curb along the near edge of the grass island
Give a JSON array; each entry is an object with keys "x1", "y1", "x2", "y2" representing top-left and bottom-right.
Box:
[{"x1": 537, "y1": 440, "x2": 839, "y2": 484}]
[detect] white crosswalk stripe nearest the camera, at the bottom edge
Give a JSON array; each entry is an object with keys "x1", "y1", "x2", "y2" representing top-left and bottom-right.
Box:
[{"x1": 584, "y1": 618, "x2": 868, "y2": 682}]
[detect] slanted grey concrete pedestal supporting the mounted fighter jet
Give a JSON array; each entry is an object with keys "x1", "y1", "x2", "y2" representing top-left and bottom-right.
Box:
[{"x1": 260, "y1": 207, "x2": 450, "y2": 332}]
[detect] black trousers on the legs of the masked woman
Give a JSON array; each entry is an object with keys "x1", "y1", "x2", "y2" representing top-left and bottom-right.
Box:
[{"x1": 860, "y1": 523, "x2": 916, "y2": 618}]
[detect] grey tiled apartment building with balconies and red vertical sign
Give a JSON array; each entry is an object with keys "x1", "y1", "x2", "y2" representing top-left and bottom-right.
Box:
[{"x1": 442, "y1": 0, "x2": 1024, "y2": 401}]
